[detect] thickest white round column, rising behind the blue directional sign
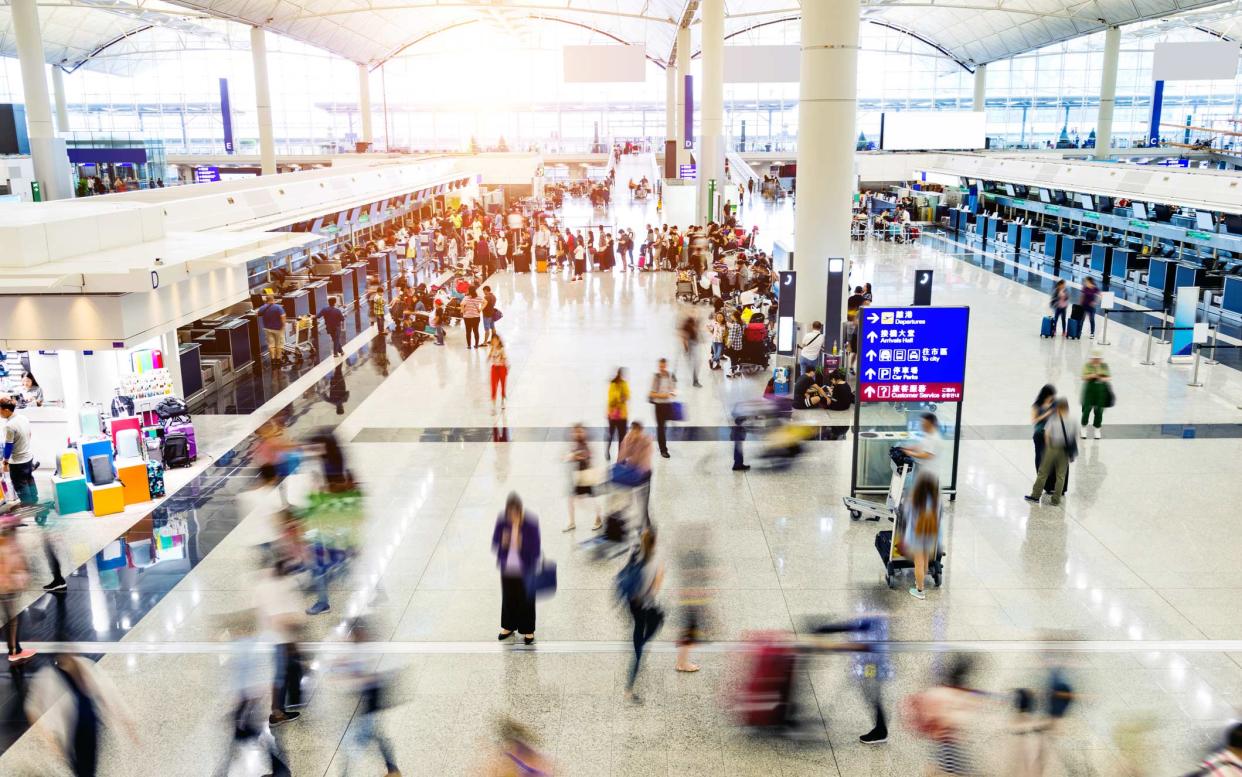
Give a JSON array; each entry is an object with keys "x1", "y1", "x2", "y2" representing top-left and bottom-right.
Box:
[{"x1": 794, "y1": 0, "x2": 861, "y2": 327}]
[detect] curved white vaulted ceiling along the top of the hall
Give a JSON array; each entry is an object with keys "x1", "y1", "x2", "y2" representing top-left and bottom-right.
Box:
[{"x1": 9, "y1": 0, "x2": 1242, "y2": 71}]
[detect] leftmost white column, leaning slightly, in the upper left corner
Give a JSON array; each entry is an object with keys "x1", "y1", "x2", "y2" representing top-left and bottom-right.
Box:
[{"x1": 9, "y1": 0, "x2": 73, "y2": 200}]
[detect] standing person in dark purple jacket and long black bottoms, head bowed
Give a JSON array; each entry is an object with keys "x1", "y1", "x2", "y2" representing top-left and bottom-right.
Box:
[{"x1": 492, "y1": 493, "x2": 543, "y2": 645}]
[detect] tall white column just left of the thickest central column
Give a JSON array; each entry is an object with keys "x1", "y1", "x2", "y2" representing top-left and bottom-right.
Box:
[{"x1": 698, "y1": 0, "x2": 725, "y2": 222}]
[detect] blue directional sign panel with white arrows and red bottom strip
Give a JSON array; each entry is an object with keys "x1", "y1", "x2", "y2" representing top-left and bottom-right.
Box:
[{"x1": 858, "y1": 307, "x2": 970, "y2": 402}]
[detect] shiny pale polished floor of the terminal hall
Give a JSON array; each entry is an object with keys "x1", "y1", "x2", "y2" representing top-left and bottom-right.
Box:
[{"x1": 0, "y1": 160, "x2": 1242, "y2": 776}]
